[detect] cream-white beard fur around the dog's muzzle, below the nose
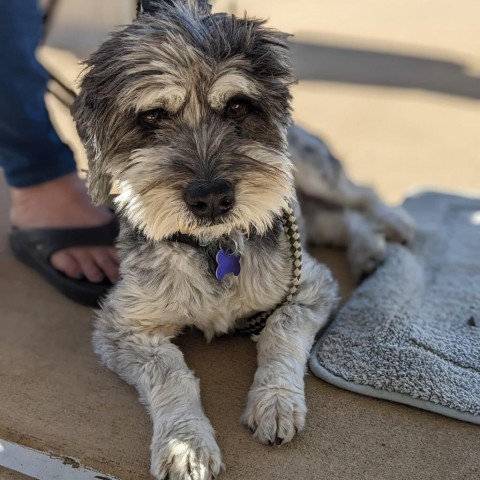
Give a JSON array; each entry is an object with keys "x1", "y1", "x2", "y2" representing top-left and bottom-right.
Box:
[{"x1": 114, "y1": 144, "x2": 294, "y2": 240}]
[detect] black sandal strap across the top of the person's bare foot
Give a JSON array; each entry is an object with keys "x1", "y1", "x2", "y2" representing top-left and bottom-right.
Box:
[{"x1": 10, "y1": 216, "x2": 120, "y2": 261}]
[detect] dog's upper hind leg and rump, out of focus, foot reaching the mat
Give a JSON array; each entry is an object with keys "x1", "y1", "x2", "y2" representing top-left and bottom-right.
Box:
[{"x1": 288, "y1": 125, "x2": 414, "y2": 246}]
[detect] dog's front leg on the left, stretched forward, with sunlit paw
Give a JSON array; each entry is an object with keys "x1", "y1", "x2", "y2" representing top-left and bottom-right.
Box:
[{"x1": 93, "y1": 310, "x2": 223, "y2": 480}]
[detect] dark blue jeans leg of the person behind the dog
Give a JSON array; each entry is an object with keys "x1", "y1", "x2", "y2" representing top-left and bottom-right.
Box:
[{"x1": 0, "y1": 0, "x2": 76, "y2": 187}]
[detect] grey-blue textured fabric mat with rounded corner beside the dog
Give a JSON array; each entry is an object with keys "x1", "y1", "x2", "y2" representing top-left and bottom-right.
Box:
[{"x1": 310, "y1": 192, "x2": 480, "y2": 424}]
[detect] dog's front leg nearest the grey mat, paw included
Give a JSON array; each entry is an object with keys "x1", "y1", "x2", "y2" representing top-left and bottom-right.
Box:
[{"x1": 242, "y1": 254, "x2": 337, "y2": 444}]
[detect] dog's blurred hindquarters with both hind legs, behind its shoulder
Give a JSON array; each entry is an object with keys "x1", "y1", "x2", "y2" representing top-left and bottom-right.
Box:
[{"x1": 288, "y1": 125, "x2": 414, "y2": 279}]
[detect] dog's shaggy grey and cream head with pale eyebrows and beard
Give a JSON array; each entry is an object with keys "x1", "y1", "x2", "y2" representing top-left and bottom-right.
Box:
[{"x1": 73, "y1": 0, "x2": 293, "y2": 239}]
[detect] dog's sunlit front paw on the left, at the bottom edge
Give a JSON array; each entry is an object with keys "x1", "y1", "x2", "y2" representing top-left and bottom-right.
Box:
[{"x1": 151, "y1": 426, "x2": 225, "y2": 480}]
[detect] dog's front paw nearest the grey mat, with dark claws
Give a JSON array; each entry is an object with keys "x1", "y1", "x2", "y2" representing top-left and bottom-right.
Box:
[{"x1": 242, "y1": 386, "x2": 307, "y2": 445}]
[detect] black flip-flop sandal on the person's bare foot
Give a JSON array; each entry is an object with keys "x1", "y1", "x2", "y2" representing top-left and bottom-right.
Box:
[{"x1": 9, "y1": 217, "x2": 119, "y2": 307}]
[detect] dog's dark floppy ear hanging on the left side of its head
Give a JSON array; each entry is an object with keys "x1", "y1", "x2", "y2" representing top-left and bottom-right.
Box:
[{"x1": 72, "y1": 88, "x2": 112, "y2": 205}]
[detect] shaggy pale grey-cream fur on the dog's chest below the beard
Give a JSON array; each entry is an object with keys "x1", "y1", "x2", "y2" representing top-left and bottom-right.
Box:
[{"x1": 113, "y1": 233, "x2": 292, "y2": 337}]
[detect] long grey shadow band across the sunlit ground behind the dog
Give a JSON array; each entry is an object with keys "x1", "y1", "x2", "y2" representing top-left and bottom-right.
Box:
[{"x1": 291, "y1": 41, "x2": 480, "y2": 100}]
